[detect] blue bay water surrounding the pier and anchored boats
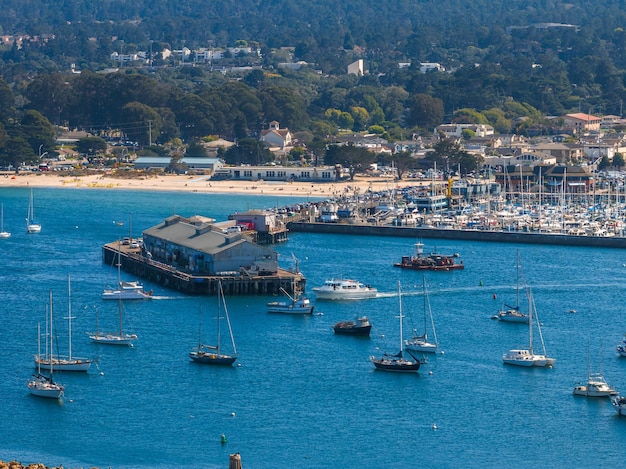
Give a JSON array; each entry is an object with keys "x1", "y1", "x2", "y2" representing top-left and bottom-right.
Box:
[{"x1": 0, "y1": 189, "x2": 626, "y2": 469}]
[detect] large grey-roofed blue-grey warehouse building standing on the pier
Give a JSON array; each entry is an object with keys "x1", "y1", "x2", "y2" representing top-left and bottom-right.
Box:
[{"x1": 143, "y1": 215, "x2": 278, "y2": 275}]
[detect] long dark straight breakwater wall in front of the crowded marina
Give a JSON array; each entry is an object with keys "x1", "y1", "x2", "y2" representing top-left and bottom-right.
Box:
[{"x1": 287, "y1": 221, "x2": 626, "y2": 248}]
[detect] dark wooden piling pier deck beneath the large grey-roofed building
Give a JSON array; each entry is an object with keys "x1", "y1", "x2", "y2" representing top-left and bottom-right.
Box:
[{"x1": 102, "y1": 242, "x2": 306, "y2": 296}]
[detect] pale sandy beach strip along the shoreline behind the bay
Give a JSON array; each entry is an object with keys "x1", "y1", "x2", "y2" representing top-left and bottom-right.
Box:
[{"x1": 0, "y1": 172, "x2": 422, "y2": 197}]
